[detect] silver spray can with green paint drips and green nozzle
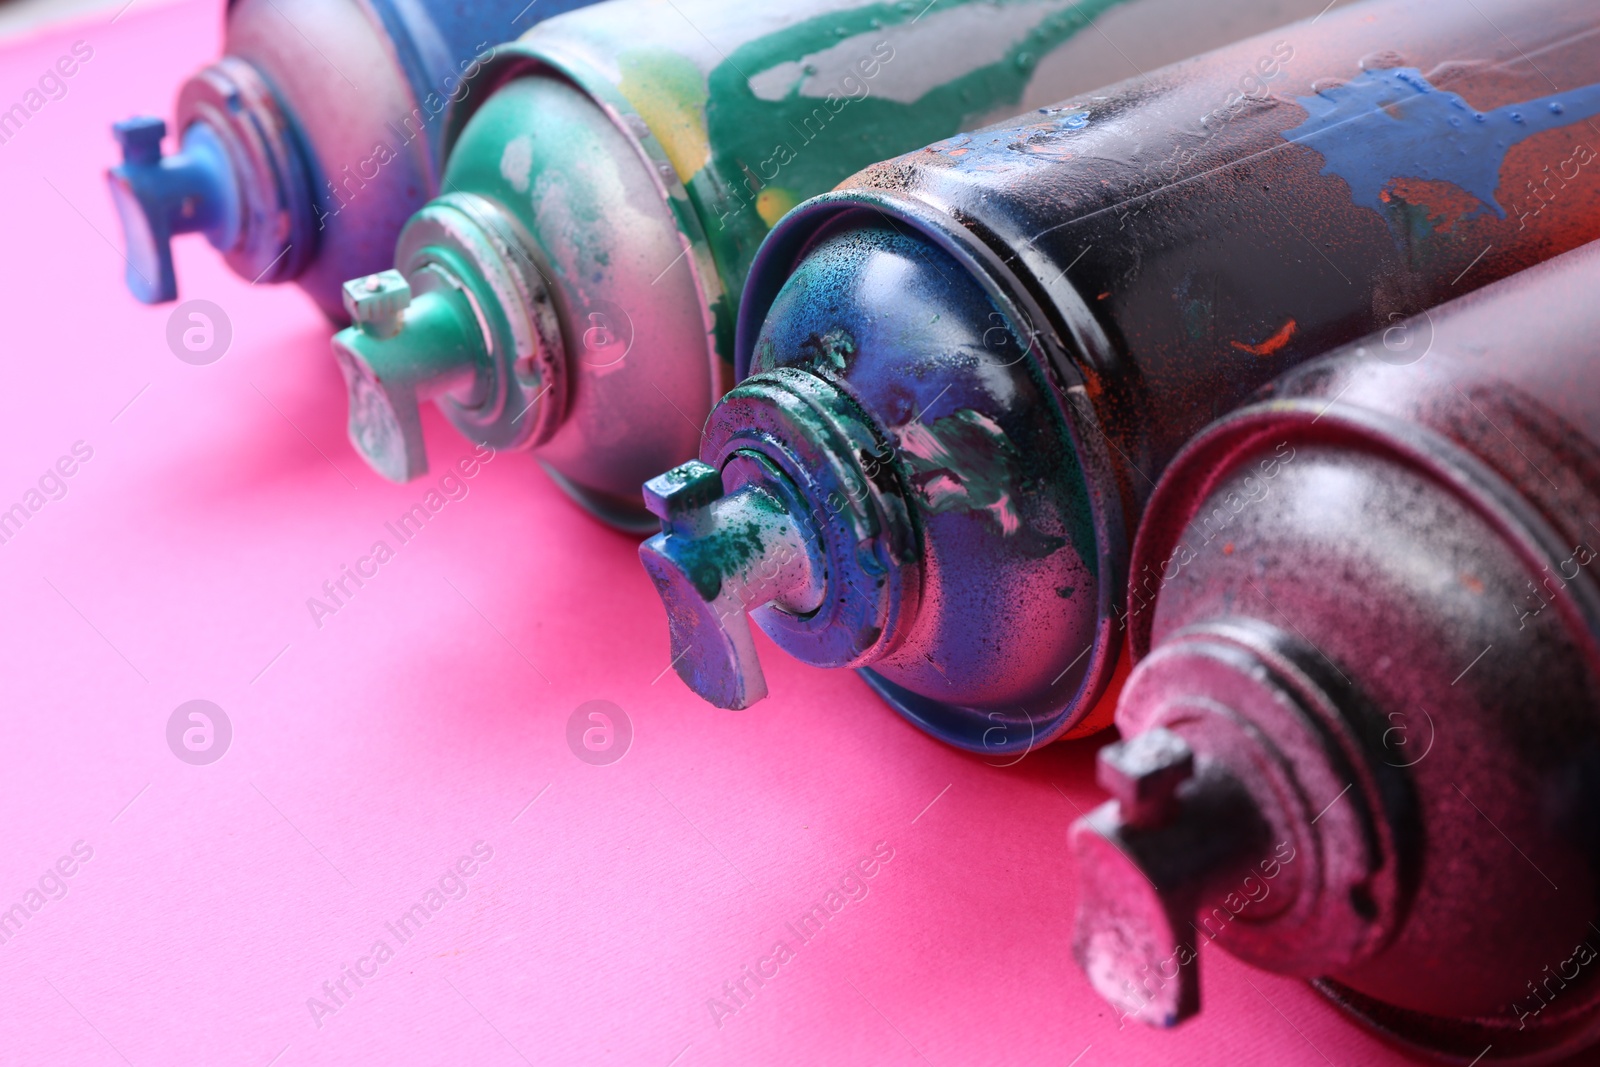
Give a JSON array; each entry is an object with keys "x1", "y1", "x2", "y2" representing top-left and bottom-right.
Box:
[{"x1": 334, "y1": 0, "x2": 1344, "y2": 531}]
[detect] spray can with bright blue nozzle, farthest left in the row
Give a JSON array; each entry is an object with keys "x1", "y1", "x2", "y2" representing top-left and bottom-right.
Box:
[{"x1": 109, "y1": 0, "x2": 592, "y2": 322}]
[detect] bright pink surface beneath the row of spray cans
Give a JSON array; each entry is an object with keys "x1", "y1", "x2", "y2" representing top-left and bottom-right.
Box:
[{"x1": 0, "y1": 0, "x2": 1440, "y2": 1067}]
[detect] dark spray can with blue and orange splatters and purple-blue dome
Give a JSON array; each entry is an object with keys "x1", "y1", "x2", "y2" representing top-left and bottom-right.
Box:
[{"x1": 642, "y1": 0, "x2": 1600, "y2": 753}]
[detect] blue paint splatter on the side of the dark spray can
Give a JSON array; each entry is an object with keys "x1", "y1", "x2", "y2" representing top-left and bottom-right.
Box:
[{"x1": 1283, "y1": 67, "x2": 1600, "y2": 219}]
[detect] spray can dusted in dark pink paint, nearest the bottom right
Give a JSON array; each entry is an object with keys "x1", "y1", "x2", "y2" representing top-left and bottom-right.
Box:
[{"x1": 1072, "y1": 238, "x2": 1600, "y2": 1064}]
